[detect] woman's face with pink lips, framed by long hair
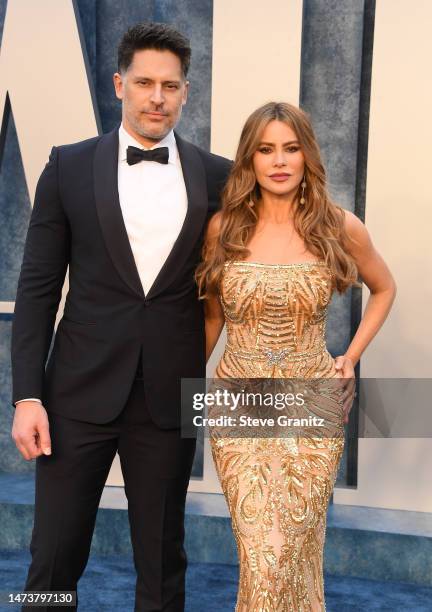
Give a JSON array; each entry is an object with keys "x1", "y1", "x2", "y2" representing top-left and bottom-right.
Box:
[{"x1": 253, "y1": 120, "x2": 305, "y2": 202}]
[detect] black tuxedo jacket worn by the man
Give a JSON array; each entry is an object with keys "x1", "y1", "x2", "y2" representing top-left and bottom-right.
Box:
[{"x1": 12, "y1": 128, "x2": 231, "y2": 428}]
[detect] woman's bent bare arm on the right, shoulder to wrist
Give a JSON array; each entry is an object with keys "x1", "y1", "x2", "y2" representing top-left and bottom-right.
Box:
[{"x1": 344, "y1": 211, "x2": 396, "y2": 366}]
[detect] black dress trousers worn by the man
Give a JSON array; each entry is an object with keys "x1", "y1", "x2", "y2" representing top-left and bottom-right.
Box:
[{"x1": 22, "y1": 366, "x2": 195, "y2": 612}]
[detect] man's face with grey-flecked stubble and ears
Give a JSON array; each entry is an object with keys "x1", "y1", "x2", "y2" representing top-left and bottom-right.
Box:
[{"x1": 114, "y1": 49, "x2": 189, "y2": 146}]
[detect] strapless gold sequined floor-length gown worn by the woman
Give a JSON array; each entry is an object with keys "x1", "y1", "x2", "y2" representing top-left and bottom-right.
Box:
[{"x1": 210, "y1": 261, "x2": 344, "y2": 612}]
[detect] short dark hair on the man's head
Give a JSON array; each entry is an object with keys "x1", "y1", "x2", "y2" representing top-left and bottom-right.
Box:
[{"x1": 117, "y1": 22, "x2": 191, "y2": 78}]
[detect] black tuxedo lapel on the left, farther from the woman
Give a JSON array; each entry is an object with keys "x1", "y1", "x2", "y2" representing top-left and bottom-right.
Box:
[{"x1": 93, "y1": 127, "x2": 144, "y2": 298}]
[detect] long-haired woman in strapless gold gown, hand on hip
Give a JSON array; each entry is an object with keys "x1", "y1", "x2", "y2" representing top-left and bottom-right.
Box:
[{"x1": 197, "y1": 102, "x2": 396, "y2": 612}]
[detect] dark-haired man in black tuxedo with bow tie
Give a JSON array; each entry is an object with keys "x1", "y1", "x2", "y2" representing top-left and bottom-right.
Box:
[{"x1": 12, "y1": 24, "x2": 230, "y2": 612}]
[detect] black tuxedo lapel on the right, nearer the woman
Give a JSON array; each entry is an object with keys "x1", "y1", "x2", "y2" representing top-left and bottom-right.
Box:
[{"x1": 147, "y1": 134, "x2": 208, "y2": 298}]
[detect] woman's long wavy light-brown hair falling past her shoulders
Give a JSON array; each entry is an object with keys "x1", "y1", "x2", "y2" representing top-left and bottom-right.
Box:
[{"x1": 195, "y1": 102, "x2": 358, "y2": 299}]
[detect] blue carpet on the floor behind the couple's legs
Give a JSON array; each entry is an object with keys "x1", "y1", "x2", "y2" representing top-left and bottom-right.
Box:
[{"x1": 0, "y1": 551, "x2": 432, "y2": 612}]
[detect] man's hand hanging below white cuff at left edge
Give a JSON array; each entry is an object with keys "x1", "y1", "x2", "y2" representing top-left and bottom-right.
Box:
[{"x1": 11, "y1": 401, "x2": 51, "y2": 461}]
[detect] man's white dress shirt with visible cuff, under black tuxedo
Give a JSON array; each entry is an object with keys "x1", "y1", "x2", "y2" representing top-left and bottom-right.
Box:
[{"x1": 15, "y1": 124, "x2": 187, "y2": 405}]
